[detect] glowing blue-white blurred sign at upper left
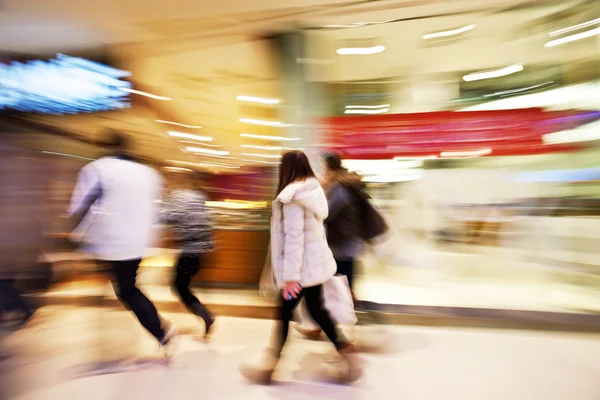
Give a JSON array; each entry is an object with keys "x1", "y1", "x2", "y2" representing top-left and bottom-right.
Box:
[{"x1": 0, "y1": 54, "x2": 131, "y2": 115}]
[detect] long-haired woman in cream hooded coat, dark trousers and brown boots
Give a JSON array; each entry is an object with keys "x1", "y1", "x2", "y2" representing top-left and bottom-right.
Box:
[{"x1": 242, "y1": 150, "x2": 361, "y2": 384}]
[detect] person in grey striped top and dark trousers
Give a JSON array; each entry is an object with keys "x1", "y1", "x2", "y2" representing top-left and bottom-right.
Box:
[{"x1": 161, "y1": 172, "x2": 215, "y2": 339}]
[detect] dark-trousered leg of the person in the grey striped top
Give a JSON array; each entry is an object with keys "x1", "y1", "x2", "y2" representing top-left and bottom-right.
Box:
[{"x1": 174, "y1": 253, "x2": 215, "y2": 336}]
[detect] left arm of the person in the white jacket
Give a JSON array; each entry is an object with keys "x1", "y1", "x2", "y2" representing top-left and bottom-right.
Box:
[{"x1": 68, "y1": 164, "x2": 102, "y2": 229}]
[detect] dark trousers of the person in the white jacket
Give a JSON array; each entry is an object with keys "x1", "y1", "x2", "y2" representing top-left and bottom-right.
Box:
[{"x1": 110, "y1": 259, "x2": 165, "y2": 341}]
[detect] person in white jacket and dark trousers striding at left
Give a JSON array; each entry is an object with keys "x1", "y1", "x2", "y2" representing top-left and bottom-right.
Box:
[{"x1": 69, "y1": 132, "x2": 176, "y2": 355}]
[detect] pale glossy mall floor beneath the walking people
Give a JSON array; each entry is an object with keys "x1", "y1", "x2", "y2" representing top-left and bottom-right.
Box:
[{"x1": 0, "y1": 307, "x2": 600, "y2": 400}]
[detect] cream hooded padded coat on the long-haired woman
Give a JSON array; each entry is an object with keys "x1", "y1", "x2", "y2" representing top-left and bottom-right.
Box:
[{"x1": 271, "y1": 178, "x2": 336, "y2": 288}]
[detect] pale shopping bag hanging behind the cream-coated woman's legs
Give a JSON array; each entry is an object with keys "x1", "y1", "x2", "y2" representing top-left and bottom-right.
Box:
[{"x1": 323, "y1": 275, "x2": 358, "y2": 325}]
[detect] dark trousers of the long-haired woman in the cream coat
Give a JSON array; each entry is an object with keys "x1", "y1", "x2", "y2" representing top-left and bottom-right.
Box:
[{"x1": 275, "y1": 285, "x2": 347, "y2": 355}]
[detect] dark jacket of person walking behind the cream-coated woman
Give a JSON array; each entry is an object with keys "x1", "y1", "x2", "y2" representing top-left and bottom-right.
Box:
[{"x1": 325, "y1": 173, "x2": 365, "y2": 260}]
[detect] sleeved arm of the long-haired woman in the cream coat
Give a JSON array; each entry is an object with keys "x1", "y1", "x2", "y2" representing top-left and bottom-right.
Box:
[{"x1": 283, "y1": 203, "x2": 304, "y2": 284}]
